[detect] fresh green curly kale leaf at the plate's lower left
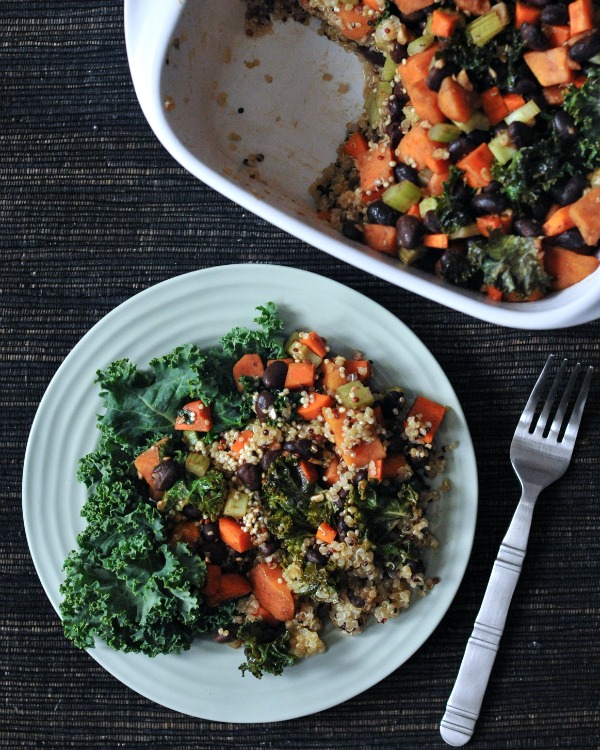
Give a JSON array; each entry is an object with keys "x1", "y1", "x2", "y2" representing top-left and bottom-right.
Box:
[{"x1": 60, "y1": 503, "x2": 206, "y2": 656}]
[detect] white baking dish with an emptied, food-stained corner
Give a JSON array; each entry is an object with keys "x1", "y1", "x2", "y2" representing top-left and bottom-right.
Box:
[{"x1": 125, "y1": 0, "x2": 600, "y2": 329}]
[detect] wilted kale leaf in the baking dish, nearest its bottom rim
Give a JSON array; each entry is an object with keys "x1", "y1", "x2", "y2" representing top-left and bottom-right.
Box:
[{"x1": 468, "y1": 232, "x2": 550, "y2": 297}]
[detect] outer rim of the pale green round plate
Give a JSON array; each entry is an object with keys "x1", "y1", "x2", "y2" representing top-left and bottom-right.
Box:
[{"x1": 22, "y1": 263, "x2": 478, "y2": 723}]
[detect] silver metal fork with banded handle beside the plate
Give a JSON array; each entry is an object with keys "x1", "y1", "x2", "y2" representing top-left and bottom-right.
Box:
[{"x1": 440, "y1": 354, "x2": 593, "y2": 747}]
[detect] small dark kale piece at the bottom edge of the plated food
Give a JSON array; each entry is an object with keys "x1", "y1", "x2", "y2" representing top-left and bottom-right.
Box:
[{"x1": 238, "y1": 620, "x2": 296, "y2": 679}]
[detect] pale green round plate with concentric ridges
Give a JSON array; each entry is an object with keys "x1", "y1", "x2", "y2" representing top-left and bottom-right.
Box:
[{"x1": 23, "y1": 265, "x2": 477, "y2": 722}]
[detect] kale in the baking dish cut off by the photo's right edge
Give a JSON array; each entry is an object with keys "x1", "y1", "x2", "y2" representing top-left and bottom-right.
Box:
[{"x1": 564, "y1": 68, "x2": 600, "y2": 171}]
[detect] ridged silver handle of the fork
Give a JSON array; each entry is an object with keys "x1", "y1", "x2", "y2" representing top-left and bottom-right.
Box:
[{"x1": 440, "y1": 493, "x2": 535, "y2": 747}]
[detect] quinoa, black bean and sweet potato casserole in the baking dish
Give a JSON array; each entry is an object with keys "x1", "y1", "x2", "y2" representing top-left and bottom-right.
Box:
[{"x1": 245, "y1": 0, "x2": 600, "y2": 302}]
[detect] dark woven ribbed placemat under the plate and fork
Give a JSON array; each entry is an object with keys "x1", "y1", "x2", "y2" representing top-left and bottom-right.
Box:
[{"x1": 0, "y1": 0, "x2": 600, "y2": 750}]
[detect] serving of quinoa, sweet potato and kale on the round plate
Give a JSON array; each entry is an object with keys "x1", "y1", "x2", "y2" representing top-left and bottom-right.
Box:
[{"x1": 61, "y1": 303, "x2": 456, "y2": 678}]
